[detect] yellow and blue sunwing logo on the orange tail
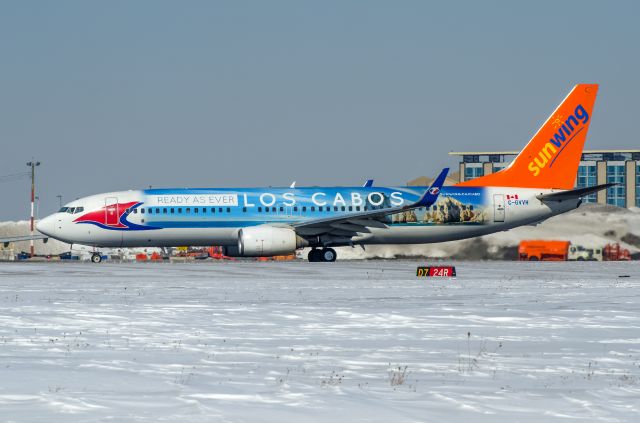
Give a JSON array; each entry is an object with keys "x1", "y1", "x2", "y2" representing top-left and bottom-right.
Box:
[{"x1": 528, "y1": 104, "x2": 589, "y2": 176}]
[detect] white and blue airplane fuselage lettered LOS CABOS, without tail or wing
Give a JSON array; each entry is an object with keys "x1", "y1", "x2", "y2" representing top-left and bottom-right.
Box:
[{"x1": 38, "y1": 186, "x2": 579, "y2": 252}]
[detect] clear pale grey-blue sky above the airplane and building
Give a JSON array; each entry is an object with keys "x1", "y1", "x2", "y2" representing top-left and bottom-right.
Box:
[{"x1": 0, "y1": 0, "x2": 640, "y2": 220}]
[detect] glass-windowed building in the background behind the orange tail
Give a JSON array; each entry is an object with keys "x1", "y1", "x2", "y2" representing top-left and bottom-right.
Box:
[{"x1": 408, "y1": 150, "x2": 640, "y2": 207}]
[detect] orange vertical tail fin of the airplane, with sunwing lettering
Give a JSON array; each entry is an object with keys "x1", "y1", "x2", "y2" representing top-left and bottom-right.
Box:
[{"x1": 457, "y1": 84, "x2": 598, "y2": 189}]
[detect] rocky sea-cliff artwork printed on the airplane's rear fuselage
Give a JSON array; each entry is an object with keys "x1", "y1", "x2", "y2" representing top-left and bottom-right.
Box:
[{"x1": 390, "y1": 187, "x2": 489, "y2": 225}]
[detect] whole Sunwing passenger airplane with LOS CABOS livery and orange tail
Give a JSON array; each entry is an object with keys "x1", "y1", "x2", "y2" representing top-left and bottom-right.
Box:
[{"x1": 37, "y1": 84, "x2": 612, "y2": 263}]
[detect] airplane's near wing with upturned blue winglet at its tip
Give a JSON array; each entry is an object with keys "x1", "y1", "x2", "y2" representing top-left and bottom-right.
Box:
[{"x1": 292, "y1": 168, "x2": 449, "y2": 243}]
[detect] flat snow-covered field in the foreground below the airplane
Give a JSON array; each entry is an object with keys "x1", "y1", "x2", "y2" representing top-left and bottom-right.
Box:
[{"x1": 0, "y1": 261, "x2": 640, "y2": 423}]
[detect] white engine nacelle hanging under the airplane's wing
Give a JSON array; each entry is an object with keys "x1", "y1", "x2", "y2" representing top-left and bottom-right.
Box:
[{"x1": 238, "y1": 225, "x2": 308, "y2": 257}]
